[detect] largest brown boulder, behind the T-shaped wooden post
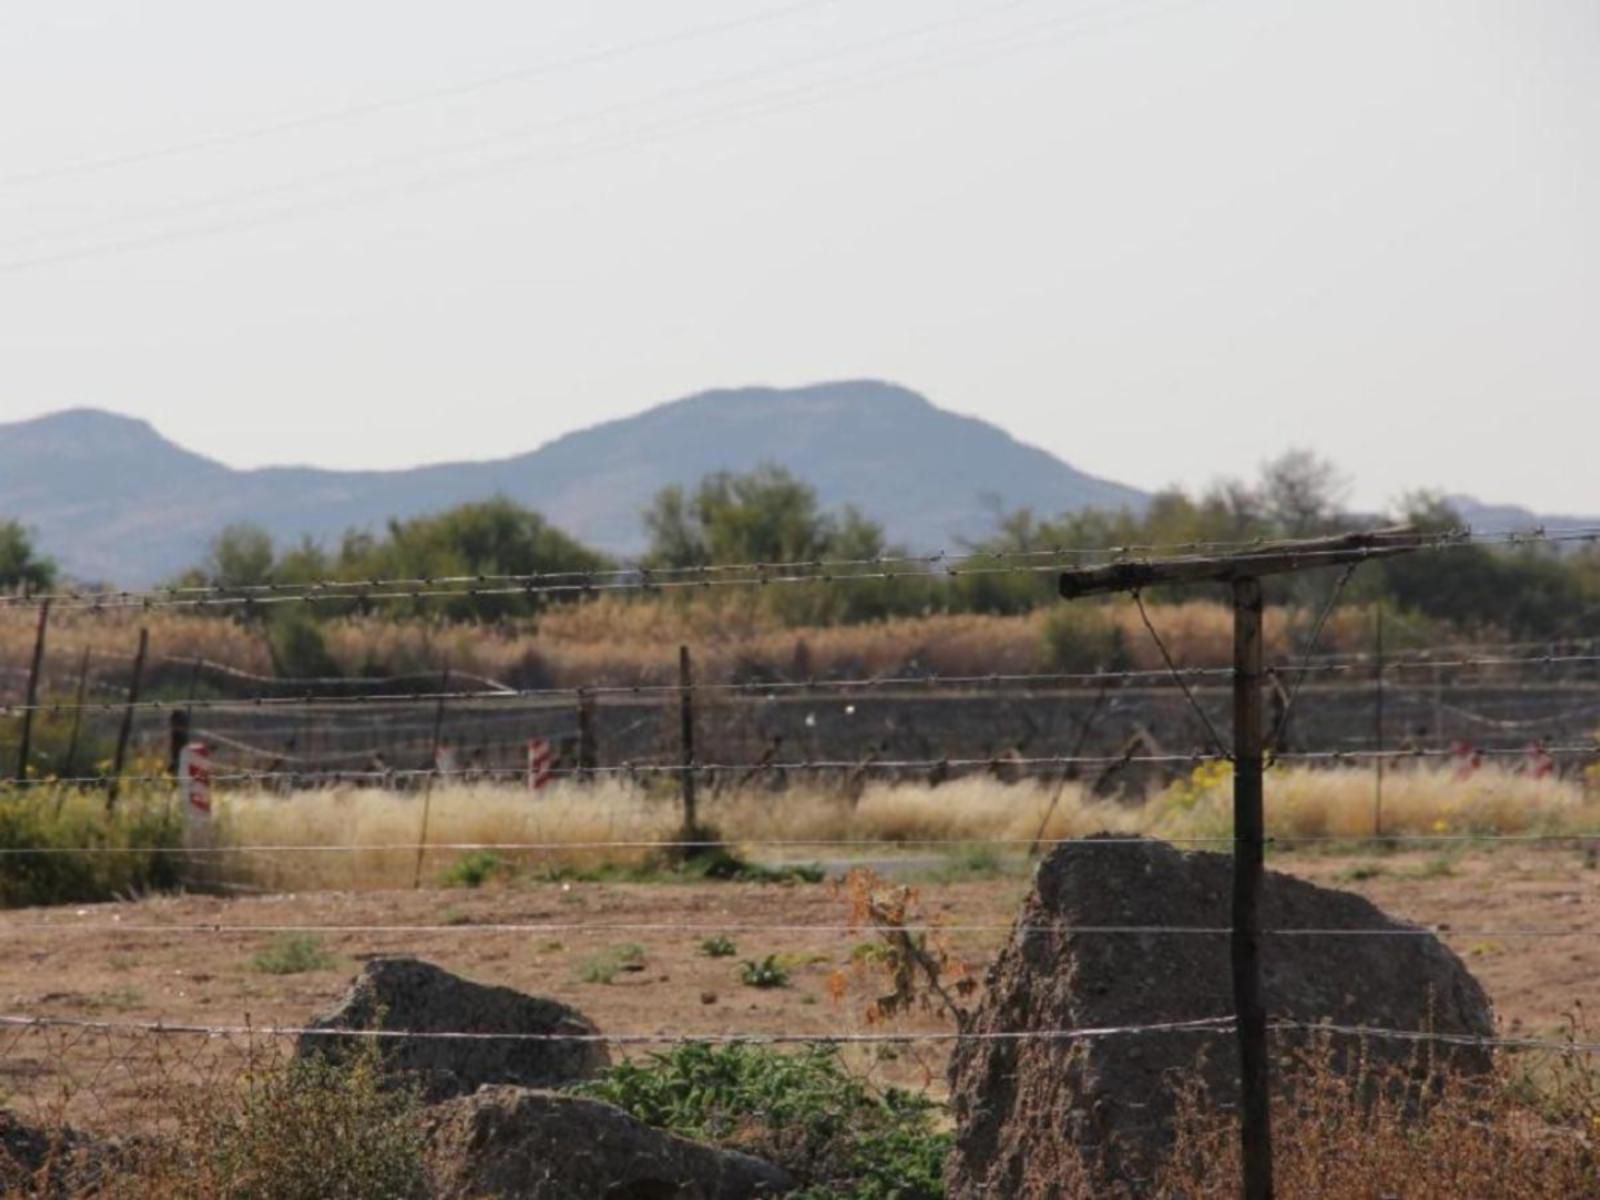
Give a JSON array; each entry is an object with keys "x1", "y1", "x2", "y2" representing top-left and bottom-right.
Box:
[{"x1": 949, "y1": 838, "x2": 1494, "y2": 1200}]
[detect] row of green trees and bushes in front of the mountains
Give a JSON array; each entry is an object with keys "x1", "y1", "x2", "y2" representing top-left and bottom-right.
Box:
[{"x1": 0, "y1": 451, "x2": 1600, "y2": 638}]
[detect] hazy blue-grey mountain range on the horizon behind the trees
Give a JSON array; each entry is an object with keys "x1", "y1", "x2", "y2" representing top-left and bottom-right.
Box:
[{"x1": 0, "y1": 379, "x2": 1146, "y2": 586}]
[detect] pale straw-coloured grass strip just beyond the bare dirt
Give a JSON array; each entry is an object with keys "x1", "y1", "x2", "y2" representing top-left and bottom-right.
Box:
[{"x1": 184, "y1": 765, "x2": 1600, "y2": 890}]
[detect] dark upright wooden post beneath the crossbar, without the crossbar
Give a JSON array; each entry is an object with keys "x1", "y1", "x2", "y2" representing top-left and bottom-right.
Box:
[{"x1": 1229, "y1": 576, "x2": 1272, "y2": 1200}]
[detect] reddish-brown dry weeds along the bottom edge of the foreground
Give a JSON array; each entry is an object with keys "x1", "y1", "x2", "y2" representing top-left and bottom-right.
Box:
[{"x1": 0, "y1": 1032, "x2": 1600, "y2": 1200}]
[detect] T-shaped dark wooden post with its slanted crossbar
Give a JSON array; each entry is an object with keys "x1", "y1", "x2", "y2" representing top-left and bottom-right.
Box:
[{"x1": 1059, "y1": 528, "x2": 1450, "y2": 1200}]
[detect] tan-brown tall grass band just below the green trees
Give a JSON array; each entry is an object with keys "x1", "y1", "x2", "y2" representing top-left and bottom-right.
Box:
[{"x1": 0, "y1": 592, "x2": 1401, "y2": 690}]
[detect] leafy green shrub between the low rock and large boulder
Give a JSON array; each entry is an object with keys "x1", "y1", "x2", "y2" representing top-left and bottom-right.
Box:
[{"x1": 578, "y1": 1045, "x2": 950, "y2": 1200}]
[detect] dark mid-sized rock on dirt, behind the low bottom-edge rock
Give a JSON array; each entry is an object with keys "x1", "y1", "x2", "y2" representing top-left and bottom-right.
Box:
[{"x1": 294, "y1": 958, "x2": 611, "y2": 1102}]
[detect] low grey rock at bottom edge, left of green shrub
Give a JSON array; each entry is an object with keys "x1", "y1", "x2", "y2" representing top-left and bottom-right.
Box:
[{"x1": 427, "y1": 1086, "x2": 794, "y2": 1200}]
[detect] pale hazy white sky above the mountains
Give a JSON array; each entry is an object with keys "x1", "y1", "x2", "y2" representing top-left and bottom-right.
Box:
[{"x1": 0, "y1": 0, "x2": 1600, "y2": 512}]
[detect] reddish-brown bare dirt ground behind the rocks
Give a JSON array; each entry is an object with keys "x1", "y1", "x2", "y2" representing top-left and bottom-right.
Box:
[{"x1": 0, "y1": 848, "x2": 1600, "y2": 1128}]
